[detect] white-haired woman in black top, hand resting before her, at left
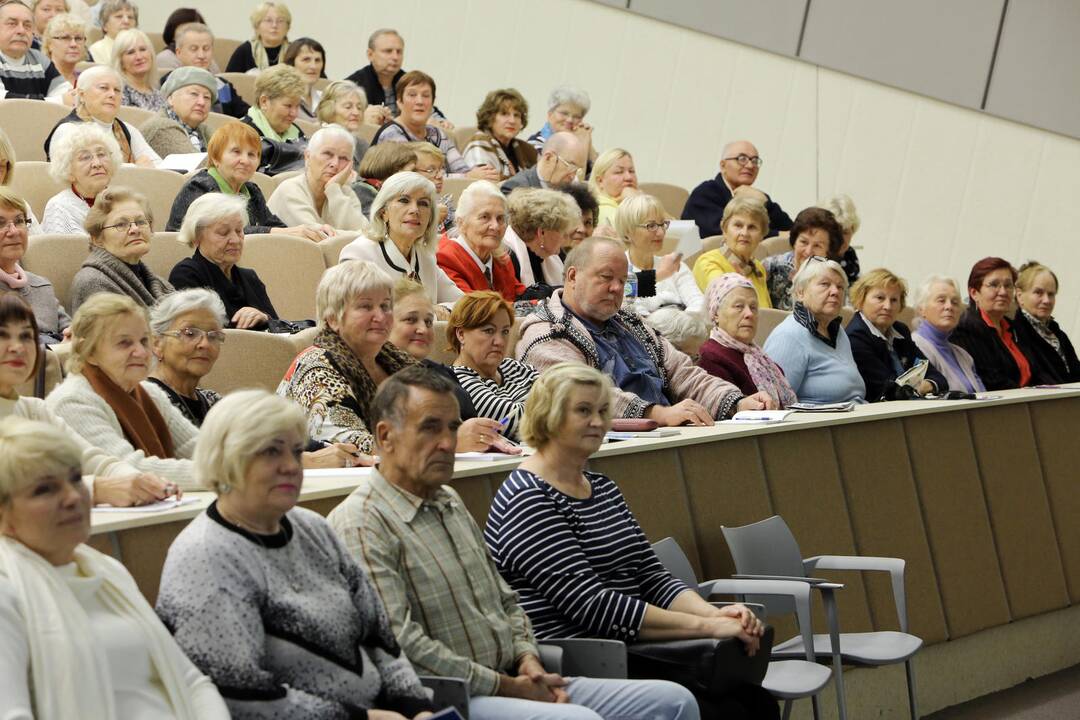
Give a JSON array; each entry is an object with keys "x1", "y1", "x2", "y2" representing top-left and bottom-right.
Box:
[{"x1": 168, "y1": 197, "x2": 278, "y2": 330}]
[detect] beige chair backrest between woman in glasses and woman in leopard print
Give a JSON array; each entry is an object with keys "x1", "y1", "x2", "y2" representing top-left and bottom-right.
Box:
[{"x1": 201, "y1": 329, "x2": 296, "y2": 395}]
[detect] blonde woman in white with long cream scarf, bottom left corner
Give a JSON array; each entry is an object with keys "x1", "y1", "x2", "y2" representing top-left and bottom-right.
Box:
[{"x1": 0, "y1": 418, "x2": 230, "y2": 720}]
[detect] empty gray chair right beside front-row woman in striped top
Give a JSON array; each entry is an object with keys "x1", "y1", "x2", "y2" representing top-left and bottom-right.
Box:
[{"x1": 652, "y1": 538, "x2": 833, "y2": 720}]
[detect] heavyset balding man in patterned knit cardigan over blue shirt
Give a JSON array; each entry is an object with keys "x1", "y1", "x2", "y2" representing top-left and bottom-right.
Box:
[{"x1": 517, "y1": 236, "x2": 775, "y2": 425}]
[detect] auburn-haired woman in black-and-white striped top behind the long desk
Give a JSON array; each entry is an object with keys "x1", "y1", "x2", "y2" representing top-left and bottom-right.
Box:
[{"x1": 446, "y1": 290, "x2": 540, "y2": 440}]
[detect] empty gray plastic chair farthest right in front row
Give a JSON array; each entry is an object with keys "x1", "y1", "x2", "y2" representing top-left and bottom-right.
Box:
[{"x1": 721, "y1": 515, "x2": 922, "y2": 720}]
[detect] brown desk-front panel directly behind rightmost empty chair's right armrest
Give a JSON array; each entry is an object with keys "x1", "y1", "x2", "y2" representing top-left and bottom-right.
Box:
[{"x1": 833, "y1": 420, "x2": 947, "y2": 644}]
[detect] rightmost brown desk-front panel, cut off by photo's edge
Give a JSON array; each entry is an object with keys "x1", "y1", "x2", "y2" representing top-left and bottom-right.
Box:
[{"x1": 1029, "y1": 398, "x2": 1080, "y2": 602}]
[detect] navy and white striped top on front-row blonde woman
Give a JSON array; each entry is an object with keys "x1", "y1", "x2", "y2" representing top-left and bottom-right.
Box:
[{"x1": 484, "y1": 470, "x2": 689, "y2": 641}]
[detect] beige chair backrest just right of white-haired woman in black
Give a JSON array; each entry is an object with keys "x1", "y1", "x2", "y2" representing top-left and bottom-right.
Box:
[{"x1": 240, "y1": 234, "x2": 326, "y2": 320}]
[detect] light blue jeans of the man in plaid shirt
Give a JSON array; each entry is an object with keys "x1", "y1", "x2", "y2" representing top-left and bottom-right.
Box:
[{"x1": 469, "y1": 678, "x2": 701, "y2": 720}]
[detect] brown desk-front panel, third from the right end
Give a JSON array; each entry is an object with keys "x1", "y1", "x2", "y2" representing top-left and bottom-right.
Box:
[{"x1": 904, "y1": 412, "x2": 1009, "y2": 638}]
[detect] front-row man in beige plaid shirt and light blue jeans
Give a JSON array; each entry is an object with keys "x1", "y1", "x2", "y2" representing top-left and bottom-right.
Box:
[{"x1": 327, "y1": 366, "x2": 699, "y2": 720}]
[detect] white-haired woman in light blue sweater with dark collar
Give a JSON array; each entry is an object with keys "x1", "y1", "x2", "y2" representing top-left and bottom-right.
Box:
[{"x1": 765, "y1": 256, "x2": 866, "y2": 403}]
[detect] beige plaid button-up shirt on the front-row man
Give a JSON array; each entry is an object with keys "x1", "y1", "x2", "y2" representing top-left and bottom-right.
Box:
[{"x1": 327, "y1": 470, "x2": 538, "y2": 695}]
